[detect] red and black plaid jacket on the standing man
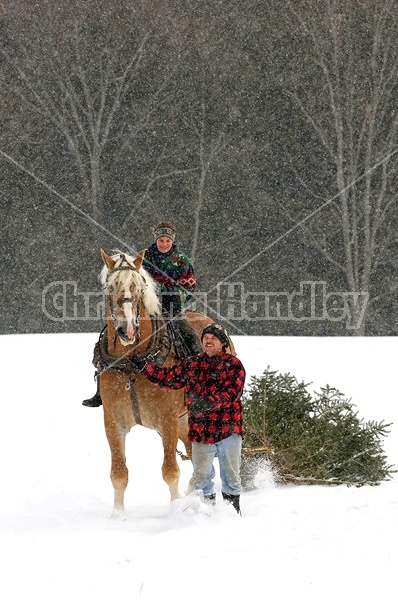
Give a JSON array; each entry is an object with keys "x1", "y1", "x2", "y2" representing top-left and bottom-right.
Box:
[{"x1": 143, "y1": 351, "x2": 246, "y2": 444}]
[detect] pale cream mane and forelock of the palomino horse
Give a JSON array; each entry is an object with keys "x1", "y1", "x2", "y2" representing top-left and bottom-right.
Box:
[{"x1": 100, "y1": 252, "x2": 161, "y2": 316}]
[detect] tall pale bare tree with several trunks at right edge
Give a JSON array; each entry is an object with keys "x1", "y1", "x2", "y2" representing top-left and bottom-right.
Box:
[{"x1": 283, "y1": 0, "x2": 398, "y2": 335}]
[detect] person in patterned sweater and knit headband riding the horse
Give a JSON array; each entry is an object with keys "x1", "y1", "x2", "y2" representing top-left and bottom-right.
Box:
[{"x1": 82, "y1": 221, "x2": 202, "y2": 407}]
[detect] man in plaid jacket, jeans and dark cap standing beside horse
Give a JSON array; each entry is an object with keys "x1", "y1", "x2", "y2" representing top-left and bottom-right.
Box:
[{"x1": 131, "y1": 323, "x2": 245, "y2": 514}]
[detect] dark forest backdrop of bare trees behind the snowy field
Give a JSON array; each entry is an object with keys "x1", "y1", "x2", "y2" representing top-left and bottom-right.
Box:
[{"x1": 0, "y1": 0, "x2": 398, "y2": 335}]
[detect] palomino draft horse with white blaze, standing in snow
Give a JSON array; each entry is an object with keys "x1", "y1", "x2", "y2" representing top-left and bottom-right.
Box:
[{"x1": 94, "y1": 249, "x2": 234, "y2": 516}]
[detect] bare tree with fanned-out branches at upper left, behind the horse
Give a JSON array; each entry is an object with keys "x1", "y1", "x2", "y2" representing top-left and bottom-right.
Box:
[{"x1": 5, "y1": 25, "x2": 155, "y2": 218}]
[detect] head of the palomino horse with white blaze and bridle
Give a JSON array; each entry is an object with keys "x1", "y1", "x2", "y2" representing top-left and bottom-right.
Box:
[{"x1": 101, "y1": 249, "x2": 160, "y2": 346}]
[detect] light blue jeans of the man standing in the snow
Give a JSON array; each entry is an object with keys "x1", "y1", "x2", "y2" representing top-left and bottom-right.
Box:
[{"x1": 192, "y1": 433, "x2": 242, "y2": 496}]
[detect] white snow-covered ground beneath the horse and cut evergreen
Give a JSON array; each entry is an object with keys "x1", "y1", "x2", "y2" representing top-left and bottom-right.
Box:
[{"x1": 0, "y1": 334, "x2": 398, "y2": 600}]
